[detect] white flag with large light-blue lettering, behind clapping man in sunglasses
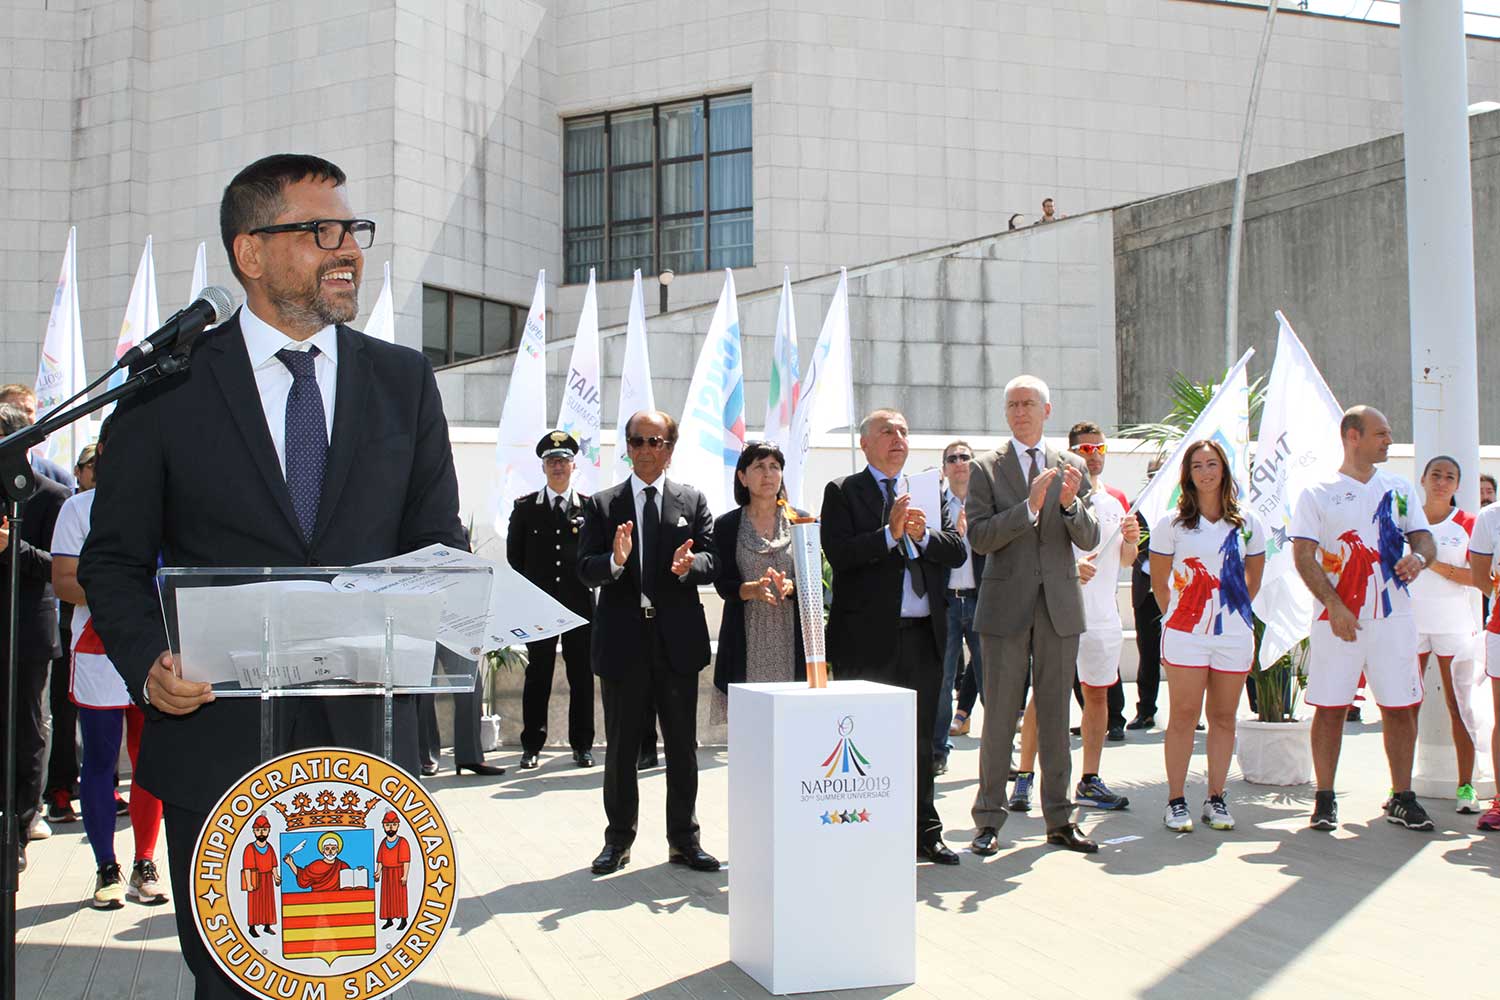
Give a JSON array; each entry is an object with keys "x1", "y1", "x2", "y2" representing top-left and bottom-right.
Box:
[{"x1": 672, "y1": 268, "x2": 746, "y2": 516}]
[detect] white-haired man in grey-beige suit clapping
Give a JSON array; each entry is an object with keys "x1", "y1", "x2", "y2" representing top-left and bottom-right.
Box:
[{"x1": 965, "y1": 375, "x2": 1100, "y2": 855}]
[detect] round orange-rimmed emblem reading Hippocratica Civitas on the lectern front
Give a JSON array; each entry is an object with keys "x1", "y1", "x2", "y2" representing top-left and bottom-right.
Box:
[{"x1": 192, "y1": 747, "x2": 458, "y2": 1000}]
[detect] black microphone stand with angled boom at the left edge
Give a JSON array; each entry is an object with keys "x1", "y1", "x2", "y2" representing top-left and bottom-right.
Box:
[{"x1": 0, "y1": 343, "x2": 191, "y2": 1000}]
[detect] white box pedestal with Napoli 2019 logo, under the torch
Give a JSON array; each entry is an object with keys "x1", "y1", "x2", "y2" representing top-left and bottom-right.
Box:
[{"x1": 729, "y1": 681, "x2": 917, "y2": 994}]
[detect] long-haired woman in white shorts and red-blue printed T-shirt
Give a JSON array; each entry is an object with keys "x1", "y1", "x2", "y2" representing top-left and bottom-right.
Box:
[{"x1": 1151, "y1": 441, "x2": 1266, "y2": 832}]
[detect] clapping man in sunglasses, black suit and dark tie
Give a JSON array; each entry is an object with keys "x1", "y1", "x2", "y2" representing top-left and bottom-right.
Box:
[{"x1": 578, "y1": 411, "x2": 719, "y2": 876}]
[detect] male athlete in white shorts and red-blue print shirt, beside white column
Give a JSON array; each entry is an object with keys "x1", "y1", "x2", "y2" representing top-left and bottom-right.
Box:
[{"x1": 1292, "y1": 406, "x2": 1437, "y2": 831}]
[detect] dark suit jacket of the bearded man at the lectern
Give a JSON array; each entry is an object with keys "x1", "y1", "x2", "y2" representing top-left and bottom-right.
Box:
[{"x1": 78, "y1": 315, "x2": 468, "y2": 813}]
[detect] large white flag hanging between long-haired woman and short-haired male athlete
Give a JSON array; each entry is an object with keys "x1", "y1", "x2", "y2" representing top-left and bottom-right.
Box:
[{"x1": 1250, "y1": 312, "x2": 1344, "y2": 666}]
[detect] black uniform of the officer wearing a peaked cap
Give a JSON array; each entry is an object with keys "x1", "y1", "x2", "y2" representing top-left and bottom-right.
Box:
[{"x1": 506, "y1": 489, "x2": 594, "y2": 753}]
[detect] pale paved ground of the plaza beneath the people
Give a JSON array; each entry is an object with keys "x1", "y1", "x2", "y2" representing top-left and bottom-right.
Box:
[{"x1": 18, "y1": 695, "x2": 1500, "y2": 1000}]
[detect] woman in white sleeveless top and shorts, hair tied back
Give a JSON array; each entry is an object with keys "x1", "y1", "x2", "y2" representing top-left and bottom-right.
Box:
[{"x1": 1412, "y1": 454, "x2": 1479, "y2": 813}]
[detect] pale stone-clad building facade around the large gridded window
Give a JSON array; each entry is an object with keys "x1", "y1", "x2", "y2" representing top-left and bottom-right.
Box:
[{"x1": 0, "y1": 0, "x2": 1500, "y2": 401}]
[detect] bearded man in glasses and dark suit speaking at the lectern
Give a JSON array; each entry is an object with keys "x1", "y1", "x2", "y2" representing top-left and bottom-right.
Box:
[{"x1": 78, "y1": 154, "x2": 468, "y2": 1000}]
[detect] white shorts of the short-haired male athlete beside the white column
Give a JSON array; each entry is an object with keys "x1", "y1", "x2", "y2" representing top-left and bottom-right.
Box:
[{"x1": 1307, "y1": 615, "x2": 1422, "y2": 708}]
